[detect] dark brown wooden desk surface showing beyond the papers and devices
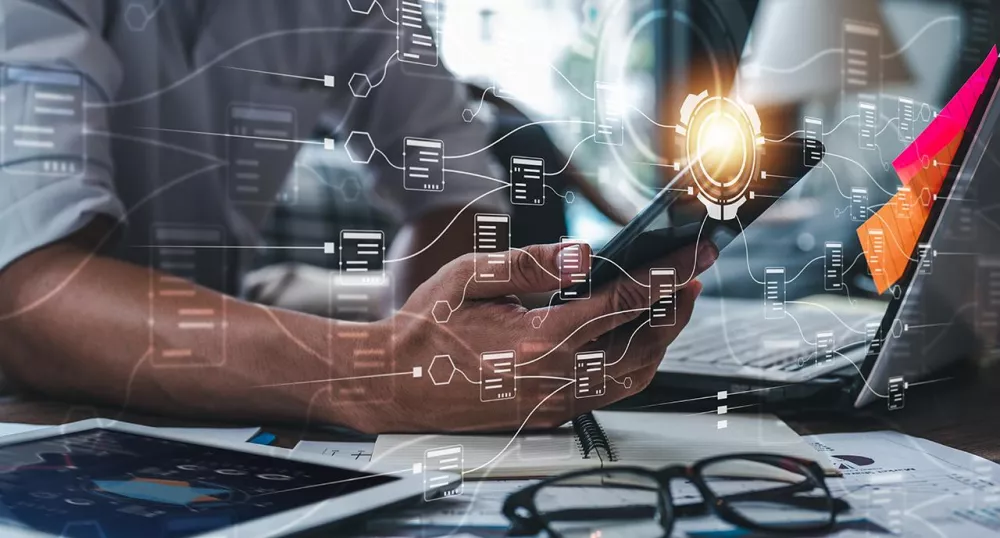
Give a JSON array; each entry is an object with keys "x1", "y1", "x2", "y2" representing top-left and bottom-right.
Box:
[{"x1": 0, "y1": 365, "x2": 1000, "y2": 456}]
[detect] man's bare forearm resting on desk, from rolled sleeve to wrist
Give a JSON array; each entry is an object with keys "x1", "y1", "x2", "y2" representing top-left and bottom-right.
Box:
[{"x1": 0, "y1": 232, "x2": 361, "y2": 425}]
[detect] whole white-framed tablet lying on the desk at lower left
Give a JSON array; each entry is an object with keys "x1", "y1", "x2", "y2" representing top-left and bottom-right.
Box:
[{"x1": 0, "y1": 419, "x2": 460, "y2": 538}]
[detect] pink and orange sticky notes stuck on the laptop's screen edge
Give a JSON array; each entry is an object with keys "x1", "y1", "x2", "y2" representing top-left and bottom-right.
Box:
[{"x1": 858, "y1": 47, "x2": 997, "y2": 293}]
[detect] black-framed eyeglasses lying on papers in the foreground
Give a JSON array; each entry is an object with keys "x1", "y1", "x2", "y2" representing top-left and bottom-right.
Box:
[{"x1": 503, "y1": 454, "x2": 850, "y2": 538}]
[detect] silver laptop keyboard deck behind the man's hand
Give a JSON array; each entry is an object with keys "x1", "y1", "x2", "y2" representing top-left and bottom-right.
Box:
[{"x1": 664, "y1": 301, "x2": 881, "y2": 375}]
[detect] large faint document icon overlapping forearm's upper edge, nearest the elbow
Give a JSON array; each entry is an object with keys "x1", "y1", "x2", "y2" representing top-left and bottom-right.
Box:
[{"x1": 150, "y1": 225, "x2": 226, "y2": 367}]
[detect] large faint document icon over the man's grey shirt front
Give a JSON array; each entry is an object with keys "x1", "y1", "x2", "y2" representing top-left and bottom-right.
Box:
[{"x1": 226, "y1": 105, "x2": 298, "y2": 205}]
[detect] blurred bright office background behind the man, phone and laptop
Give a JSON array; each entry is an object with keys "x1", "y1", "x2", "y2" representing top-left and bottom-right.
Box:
[{"x1": 257, "y1": 0, "x2": 1000, "y2": 306}]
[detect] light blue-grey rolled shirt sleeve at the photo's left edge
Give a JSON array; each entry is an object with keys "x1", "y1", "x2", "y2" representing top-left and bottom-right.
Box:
[{"x1": 0, "y1": 0, "x2": 125, "y2": 270}]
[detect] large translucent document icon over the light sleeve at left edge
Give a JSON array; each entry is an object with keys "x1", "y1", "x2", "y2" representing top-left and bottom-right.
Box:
[{"x1": 0, "y1": 67, "x2": 86, "y2": 176}]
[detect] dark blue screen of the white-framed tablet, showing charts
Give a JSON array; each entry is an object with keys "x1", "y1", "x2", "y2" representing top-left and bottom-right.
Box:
[{"x1": 0, "y1": 429, "x2": 398, "y2": 538}]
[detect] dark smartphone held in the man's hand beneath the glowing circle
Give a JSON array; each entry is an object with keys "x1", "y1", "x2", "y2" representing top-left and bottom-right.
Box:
[{"x1": 557, "y1": 138, "x2": 826, "y2": 302}]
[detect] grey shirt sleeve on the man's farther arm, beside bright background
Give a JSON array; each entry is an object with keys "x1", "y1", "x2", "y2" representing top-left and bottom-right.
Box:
[{"x1": 338, "y1": 7, "x2": 510, "y2": 221}]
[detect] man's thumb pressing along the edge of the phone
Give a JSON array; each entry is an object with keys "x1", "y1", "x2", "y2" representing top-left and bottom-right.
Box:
[{"x1": 460, "y1": 243, "x2": 590, "y2": 299}]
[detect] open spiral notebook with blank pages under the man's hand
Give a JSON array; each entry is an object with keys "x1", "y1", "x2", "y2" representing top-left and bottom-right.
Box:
[{"x1": 372, "y1": 411, "x2": 839, "y2": 479}]
